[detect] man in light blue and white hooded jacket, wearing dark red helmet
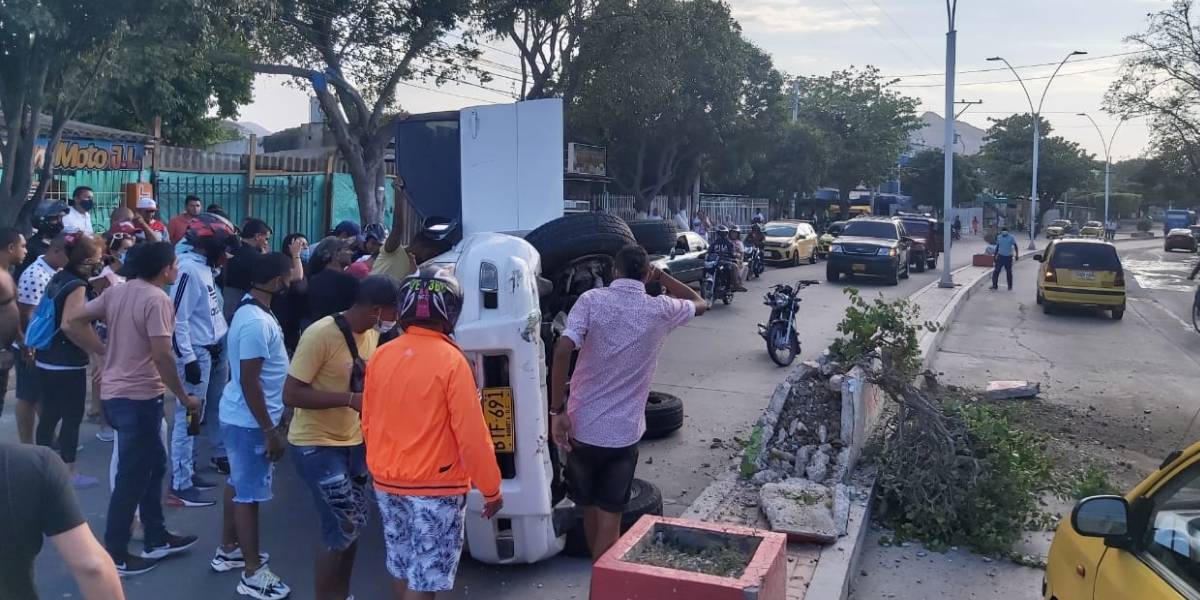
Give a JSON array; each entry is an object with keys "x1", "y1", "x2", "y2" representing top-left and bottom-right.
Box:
[{"x1": 168, "y1": 214, "x2": 235, "y2": 506}]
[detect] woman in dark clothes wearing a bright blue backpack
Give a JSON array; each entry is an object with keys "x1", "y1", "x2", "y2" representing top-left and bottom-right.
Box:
[{"x1": 25, "y1": 233, "x2": 104, "y2": 488}]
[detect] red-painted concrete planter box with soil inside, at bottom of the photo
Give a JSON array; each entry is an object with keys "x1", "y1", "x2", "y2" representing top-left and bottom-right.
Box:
[{"x1": 592, "y1": 515, "x2": 787, "y2": 600}]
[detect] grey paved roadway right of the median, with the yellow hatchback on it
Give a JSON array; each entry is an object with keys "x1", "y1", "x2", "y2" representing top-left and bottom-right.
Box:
[{"x1": 851, "y1": 241, "x2": 1200, "y2": 600}]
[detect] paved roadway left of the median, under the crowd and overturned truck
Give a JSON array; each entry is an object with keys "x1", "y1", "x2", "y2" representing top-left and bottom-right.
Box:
[{"x1": 18, "y1": 240, "x2": 983, "y2": 600}]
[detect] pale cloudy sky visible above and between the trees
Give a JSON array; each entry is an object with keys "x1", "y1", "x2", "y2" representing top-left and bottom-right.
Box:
[{"x1": 239, "y1": 0, "x2": 1169, "y2": 161}]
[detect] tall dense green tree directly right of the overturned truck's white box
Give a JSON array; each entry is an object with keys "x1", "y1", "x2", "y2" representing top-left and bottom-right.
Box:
[{"x1": 568, "y1": 0, "x2": 780, "y2": 210}]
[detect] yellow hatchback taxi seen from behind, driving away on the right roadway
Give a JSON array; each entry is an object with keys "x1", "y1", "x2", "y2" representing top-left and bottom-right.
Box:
[{"x1": 1033, "y1": 238, "x2": 1126, "y2": 319}]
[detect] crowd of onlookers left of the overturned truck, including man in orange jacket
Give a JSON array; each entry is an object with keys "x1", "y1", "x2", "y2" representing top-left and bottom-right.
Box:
[{"x1": 0, "y1": 187, "x2": 525, "y2": 600}]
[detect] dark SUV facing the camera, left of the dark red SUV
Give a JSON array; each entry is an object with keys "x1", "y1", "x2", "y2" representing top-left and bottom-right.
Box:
[{"x1": 826, "y1": 217, "x2": 912, "y2": 286}]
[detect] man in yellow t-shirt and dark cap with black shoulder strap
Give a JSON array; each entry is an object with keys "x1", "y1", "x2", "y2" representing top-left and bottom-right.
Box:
[{"x1": 283, "y1": 275, "x2": 397, "y2": 600}]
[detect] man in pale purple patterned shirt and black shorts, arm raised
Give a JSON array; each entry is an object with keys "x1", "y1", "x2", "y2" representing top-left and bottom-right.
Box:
[{"x1": 550, "y1": 246, "x2": 708, "y2": 560}]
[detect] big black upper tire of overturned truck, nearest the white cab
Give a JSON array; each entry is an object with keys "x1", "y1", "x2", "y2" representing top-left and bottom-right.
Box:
[{"x1": 526, "y1": 212, "x2": 636, "y2": 274}]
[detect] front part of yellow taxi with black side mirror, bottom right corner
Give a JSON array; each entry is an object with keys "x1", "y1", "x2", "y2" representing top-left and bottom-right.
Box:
[{"x1": 1042, "y1": 443, "x2": 1200, "y2": 600}]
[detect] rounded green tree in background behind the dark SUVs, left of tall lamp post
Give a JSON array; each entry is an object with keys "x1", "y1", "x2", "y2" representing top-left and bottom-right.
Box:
[{"x1": 796, "y1": 66, "x2": 920, "y2": 217}]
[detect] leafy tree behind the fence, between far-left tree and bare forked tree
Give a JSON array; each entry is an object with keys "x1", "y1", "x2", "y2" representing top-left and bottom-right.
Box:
[{"x1": 77, "y1": 0, "x2": 253, "y2": 146}]
